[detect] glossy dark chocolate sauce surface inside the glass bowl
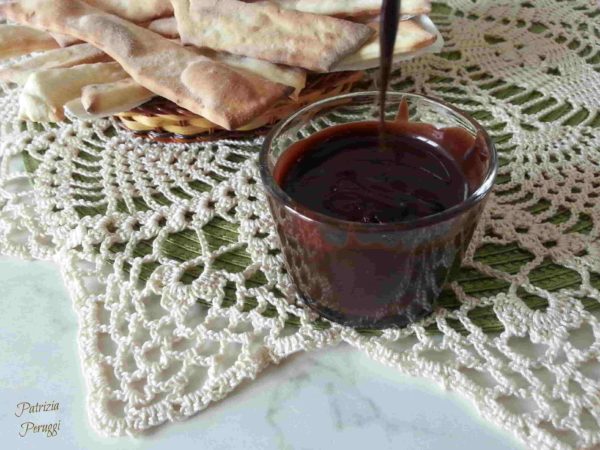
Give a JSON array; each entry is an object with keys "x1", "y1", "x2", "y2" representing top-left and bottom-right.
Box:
[{"x1": 276, "y1": 122, "x2": 468, "y2": 223}]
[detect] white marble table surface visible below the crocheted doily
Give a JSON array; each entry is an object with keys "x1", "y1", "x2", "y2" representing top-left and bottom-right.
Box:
[{"x1": 0, "y1": 257, "x2": 523, "y2": 450}]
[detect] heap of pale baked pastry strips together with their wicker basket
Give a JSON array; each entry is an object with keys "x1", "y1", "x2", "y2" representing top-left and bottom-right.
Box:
[{"x1": 0, "y1": 0, "x2": 436, "y2": 141}]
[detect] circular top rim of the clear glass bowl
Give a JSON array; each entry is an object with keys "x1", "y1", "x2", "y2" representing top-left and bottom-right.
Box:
[{"x1": 259, "y1": 91, "x2": 498, "y2": 232}]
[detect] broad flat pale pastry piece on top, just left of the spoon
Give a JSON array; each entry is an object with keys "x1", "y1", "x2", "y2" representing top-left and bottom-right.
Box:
[{"x1": 173, "y1": 0, "x2": 373, "y2": 72}]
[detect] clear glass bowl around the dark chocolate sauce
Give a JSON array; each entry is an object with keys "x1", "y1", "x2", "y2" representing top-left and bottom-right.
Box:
[{"x1": 260, "y1": 92, "x2": 498, "y2": 328}]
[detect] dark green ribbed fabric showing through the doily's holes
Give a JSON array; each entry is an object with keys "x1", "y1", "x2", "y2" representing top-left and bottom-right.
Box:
[{"x1": 19, "y1": 3, "x2": 600, "y2": 334}]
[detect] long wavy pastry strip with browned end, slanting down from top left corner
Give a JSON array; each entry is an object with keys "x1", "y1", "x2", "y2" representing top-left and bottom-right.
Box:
[{"x1": 0, "y1": 0, "x2": 289, "y2": 129}]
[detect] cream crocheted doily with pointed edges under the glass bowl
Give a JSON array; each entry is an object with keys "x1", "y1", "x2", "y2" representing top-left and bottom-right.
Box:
[{"x1": 0, "y1": 0, "x2": 600, "y2": 449}]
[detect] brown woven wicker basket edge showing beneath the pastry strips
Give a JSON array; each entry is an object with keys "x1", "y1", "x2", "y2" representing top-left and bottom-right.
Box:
[{"x1": 117, "y1": 72, "x2": 364, "y2": 142}]
